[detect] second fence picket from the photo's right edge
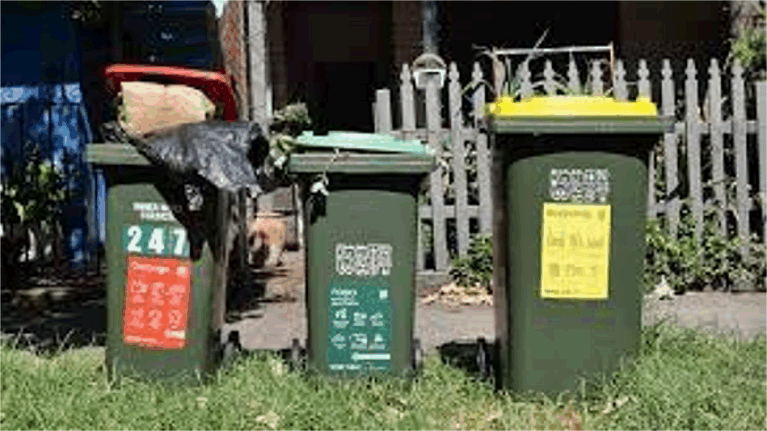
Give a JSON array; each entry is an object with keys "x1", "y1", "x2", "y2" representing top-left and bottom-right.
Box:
[{"x1": 732, "y1": 60, "x2": 751, "y2": 264}]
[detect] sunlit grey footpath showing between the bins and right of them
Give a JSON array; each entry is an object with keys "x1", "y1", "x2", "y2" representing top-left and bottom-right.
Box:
[{"x1": 225, "y1": 253, "x2": 767, "y2": 351}]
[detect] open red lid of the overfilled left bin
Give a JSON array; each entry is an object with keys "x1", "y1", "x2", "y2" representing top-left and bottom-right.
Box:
[{"x1": 104, "y1": 64, "x2": 237, "y2": 121}]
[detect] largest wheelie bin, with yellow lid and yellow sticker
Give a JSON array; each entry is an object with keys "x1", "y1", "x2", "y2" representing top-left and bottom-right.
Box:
[{"x1": 488, "y1": 96, "x2": 670, "y2": 395}]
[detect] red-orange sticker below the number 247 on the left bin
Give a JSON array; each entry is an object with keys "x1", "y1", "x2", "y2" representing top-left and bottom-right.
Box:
[{"x1": 123, "y1": 256, "x2": 192, "y2": 349}]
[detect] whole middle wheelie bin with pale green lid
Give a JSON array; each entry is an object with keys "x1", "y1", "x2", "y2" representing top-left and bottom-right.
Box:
[{"x1": 289, "y1": 132, "x2": 436, "y2": 377}]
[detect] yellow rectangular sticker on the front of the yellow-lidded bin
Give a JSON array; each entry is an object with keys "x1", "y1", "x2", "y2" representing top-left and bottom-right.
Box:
[{"x1": 541, "y1": 203, "x2": 610, "y2": 299}]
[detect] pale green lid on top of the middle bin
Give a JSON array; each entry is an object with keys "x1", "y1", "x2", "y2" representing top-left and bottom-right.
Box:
[{"x1": 297, "y1": 131, "x2": 432, "y2": 155}]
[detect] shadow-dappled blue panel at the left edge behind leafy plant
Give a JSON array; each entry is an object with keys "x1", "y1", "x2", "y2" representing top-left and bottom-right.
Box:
[{"x1": 0, "y1": 1, "x2": 106, "y2": 269}]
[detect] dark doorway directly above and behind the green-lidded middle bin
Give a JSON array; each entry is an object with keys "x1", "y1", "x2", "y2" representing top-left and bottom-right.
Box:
[{"x1": 285, "y1": 1, "x2": 391, "y2": 132}]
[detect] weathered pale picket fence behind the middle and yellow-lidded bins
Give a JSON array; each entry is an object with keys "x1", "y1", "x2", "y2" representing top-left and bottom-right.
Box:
[{"x1": 373, "y1": 55, "x2": 767, "y2": 286}]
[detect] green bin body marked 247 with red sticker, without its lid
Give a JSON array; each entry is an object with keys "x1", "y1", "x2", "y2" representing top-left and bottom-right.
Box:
[{"x1": 87, "y1": 144, "x2": 231, "y2": 382}]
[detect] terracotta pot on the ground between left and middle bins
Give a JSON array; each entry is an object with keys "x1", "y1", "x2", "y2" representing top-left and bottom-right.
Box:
[{"x1": 248, "y1": 212, "x2": 286, "y2": 268}]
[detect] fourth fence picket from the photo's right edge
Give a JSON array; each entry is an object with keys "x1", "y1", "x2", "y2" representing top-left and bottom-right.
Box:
[{"x1": 684, "y1": 58, "x2": 703, "y2": 243}]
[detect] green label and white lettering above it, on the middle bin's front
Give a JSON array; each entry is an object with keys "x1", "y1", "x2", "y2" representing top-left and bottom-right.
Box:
[{"x1": 327, "y1": 244, "x2": 391, "y2": 371}]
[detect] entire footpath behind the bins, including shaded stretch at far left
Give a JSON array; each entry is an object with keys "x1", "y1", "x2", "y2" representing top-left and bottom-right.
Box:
[{"x1": 0, "y1": 252, "x2": 767, "y2": 351}]
